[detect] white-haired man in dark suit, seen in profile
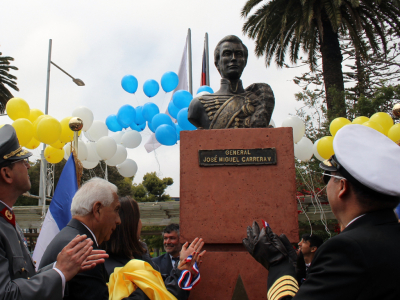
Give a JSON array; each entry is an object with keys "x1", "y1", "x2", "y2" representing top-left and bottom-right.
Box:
[{"x1": 40, "y1": 178, "x2": 121, "y2": 300}]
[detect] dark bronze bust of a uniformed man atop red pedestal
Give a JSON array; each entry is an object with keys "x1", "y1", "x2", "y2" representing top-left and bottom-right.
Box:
[{"x1": 188, "y1": 35, "x2": 275, "y2": 129}]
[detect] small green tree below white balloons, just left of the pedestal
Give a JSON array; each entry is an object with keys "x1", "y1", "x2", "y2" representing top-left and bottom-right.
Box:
[{"x1": 132, "y1": 172, "x2": 174, "y2": 202}]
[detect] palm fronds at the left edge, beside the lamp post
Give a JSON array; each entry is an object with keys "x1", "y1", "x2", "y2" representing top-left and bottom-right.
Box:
[{"x1": 0, "y1": 52, "x2": 19, "y2": 113}]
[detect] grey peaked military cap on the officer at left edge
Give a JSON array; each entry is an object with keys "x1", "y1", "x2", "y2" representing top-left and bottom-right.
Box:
[{"x1": 0, "y1": 124, "x2": 32, "y2": 167}]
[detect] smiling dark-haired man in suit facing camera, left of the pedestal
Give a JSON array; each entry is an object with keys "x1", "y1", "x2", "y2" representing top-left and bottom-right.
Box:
[{"x1": 152, "y1": 224, "x2": 190, "y2": 300}]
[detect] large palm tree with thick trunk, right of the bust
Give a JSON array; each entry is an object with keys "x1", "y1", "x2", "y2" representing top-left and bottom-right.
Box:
[{"x1": 241, "y1": 0, "x2": 400, "y2": 118}]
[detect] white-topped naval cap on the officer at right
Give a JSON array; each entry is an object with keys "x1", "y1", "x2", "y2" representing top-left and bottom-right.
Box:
[{"x1": 320, "y1": 124, "x2": 400, "y2": 197}]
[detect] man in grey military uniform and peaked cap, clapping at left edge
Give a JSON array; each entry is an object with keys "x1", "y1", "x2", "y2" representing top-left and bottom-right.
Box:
[{"x1": 0, "y1": 125, "x2": 108, "y2": 300}]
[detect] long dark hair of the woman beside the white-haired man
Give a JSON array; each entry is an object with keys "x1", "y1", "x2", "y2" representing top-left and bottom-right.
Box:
[{"x1": 102, "y1": 196, "x2": 146, "y2": 258}]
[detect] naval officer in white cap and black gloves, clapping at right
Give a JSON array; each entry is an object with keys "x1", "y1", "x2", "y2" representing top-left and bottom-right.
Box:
[{"x1": 243, "y1": 125, "x2": 400, "y2": 300}]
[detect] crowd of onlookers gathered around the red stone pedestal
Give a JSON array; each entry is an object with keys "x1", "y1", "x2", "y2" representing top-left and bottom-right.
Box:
[{"x1": 0, "y1": 118, "x2": 400, "y2": 300}]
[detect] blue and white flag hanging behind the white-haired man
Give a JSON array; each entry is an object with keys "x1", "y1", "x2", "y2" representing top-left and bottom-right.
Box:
[{"x1": 32, "y1": 153, "x2": 78, "y2": 266}]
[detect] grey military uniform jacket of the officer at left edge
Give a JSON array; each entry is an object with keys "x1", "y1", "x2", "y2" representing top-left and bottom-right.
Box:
[{"x1": 0, "y1": 203, "x2": 62, "y2": 300}]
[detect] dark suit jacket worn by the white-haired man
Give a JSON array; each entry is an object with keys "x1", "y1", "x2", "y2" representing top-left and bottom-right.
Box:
[{"x1": 40, "y1": 219, "x2": 108, "y2": 300}]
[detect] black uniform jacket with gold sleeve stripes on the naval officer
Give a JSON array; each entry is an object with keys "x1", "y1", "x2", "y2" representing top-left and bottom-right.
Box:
[{"x1": 268, "y1": 210, "x2": 400, "y2": 300}]
